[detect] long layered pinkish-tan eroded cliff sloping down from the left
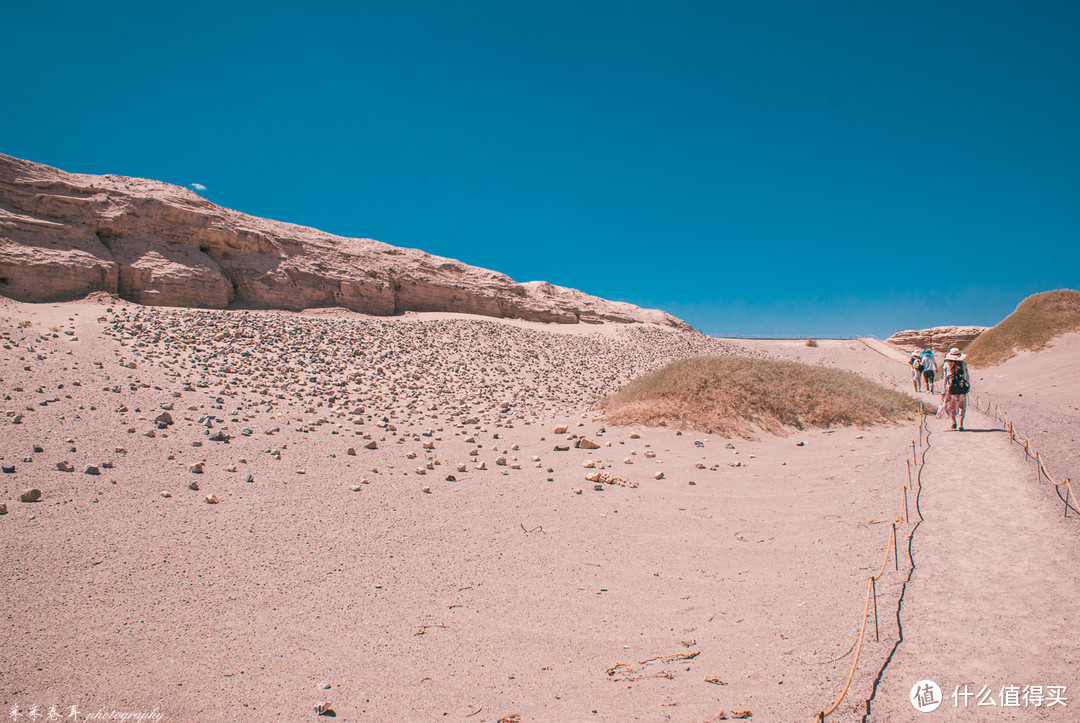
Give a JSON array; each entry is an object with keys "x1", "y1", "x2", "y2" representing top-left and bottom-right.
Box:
[{"x1": 0, "y1": 153, "x2": 689, "y2": 329}]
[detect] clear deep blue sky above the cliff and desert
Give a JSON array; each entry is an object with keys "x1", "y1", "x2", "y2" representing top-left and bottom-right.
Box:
[{"x1": 0, "y1": 0, "x2": 1080, "y2": 336}]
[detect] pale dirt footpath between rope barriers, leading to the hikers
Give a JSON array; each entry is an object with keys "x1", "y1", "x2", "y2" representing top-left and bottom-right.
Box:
[{"x1": 868, "y1": 412, "x2": 1080, "y2": 721}]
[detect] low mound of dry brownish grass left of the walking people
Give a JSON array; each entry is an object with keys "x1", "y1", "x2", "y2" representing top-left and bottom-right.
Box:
[{"x1": 603, "y1": 357, "x2": 920, "y2": 439}]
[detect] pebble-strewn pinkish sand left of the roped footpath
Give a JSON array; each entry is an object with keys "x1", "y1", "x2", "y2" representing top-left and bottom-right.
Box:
[{"x1": 0, "y1": 300, "x2": 1076, "y2": 722}]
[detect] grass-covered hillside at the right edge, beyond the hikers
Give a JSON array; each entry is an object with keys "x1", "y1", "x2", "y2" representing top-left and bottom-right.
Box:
[{"x1": 964, "y1": 289, "x2": 1080, "y2": 366}]
